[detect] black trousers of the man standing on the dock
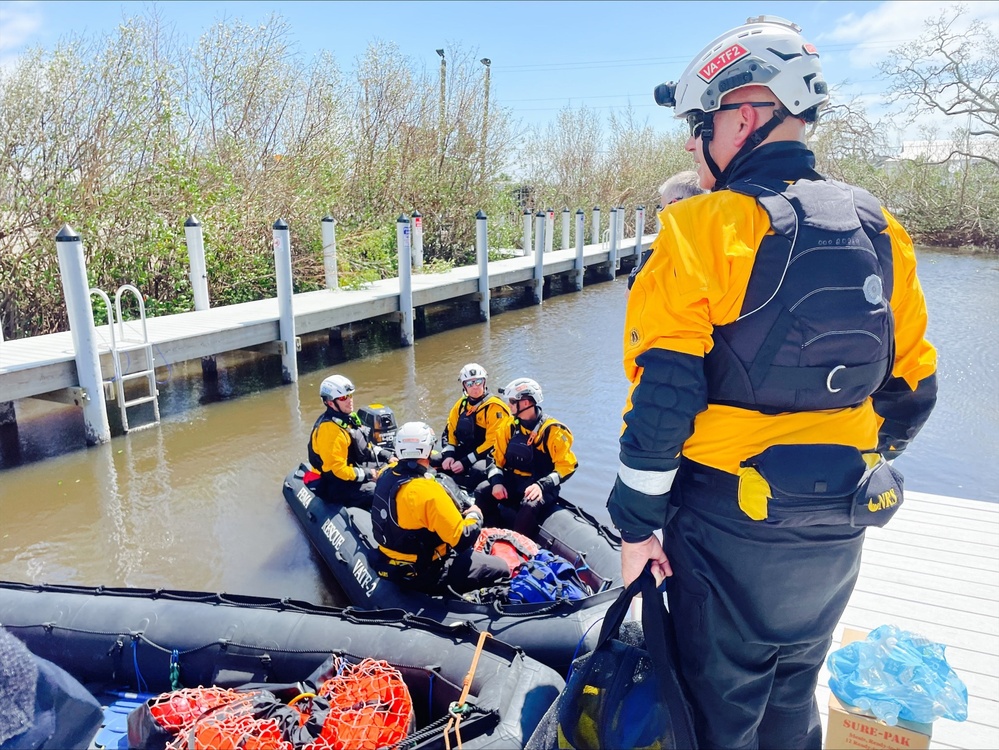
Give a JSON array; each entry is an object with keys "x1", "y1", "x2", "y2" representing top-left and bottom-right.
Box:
[{"x1": 663, "y1": 465, "x2": 864, "y2": 750}]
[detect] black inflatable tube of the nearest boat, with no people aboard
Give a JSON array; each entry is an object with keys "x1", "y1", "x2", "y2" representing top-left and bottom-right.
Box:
[{"x1": 0, "y1": 582, "x2": 564, "y2": 748}]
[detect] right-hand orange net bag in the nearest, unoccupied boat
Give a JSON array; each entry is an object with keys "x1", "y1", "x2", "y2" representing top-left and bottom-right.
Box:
[{"x1": 318, "y1": 659, "x2": 413, "y2": 750}]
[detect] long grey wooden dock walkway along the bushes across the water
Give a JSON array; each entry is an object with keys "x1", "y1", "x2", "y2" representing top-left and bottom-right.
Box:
[{"x1": 0, "y1": 235, "x2": 655, "y2": 402}]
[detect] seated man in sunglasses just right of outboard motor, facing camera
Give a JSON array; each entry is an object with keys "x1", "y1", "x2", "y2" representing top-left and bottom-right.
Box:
[{"x1": 441, "y1": 362, "x2": 510, "y2": 490}]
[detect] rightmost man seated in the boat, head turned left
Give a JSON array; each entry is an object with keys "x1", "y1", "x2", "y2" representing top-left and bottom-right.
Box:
[{"x1": 475, "y1": 378, "x2": 579, "y2": 539}]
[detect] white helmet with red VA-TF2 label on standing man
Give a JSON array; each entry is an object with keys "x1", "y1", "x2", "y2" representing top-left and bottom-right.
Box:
[{"x1": 655, "y1": 16, "x2": 829, "y2": 121}]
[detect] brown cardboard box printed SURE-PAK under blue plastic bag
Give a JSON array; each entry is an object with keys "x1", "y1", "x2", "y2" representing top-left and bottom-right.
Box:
[{"x1": 825, "y1": 628, "x2": 933, "y2": 750}]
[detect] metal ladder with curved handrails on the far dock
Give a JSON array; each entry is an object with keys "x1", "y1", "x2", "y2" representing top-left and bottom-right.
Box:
[{"x1": 90, "y1": 284, "x2": 160, "y2": 432}]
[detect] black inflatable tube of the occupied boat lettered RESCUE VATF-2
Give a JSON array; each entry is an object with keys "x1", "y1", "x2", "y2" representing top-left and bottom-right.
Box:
[{"x1": 284, "y1": 468, "x2": 621, "y2": 674}]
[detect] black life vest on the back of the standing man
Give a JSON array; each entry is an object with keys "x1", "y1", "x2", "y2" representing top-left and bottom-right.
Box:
[{"x1": 704, "y1": 180, "x2": 894, "y2": 414}]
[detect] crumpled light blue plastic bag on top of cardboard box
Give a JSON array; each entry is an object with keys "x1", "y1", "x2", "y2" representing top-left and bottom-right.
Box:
[{"x1": 826, "y1": 625, "x2": 968, "y2": 726}]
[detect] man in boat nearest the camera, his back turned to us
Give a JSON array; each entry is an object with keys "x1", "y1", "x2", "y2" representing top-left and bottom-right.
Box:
[{"x1": 371, "y1": 422, "x2": 510, "y2": 594}]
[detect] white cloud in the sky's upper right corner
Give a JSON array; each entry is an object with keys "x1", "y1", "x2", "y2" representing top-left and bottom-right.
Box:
[{"x1": 816, "y1": 0, "x2": 999, "y2": 68}]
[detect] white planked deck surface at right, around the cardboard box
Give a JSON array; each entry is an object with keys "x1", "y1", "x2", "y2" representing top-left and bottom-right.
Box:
[{"x1": 818, "y1": 490, "x2": 999, "y2": 748}]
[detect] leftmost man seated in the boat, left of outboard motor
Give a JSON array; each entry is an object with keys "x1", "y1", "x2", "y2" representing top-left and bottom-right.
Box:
[{"x1": 305, "y1": 375, "x2": 392, "y2": 508}]
